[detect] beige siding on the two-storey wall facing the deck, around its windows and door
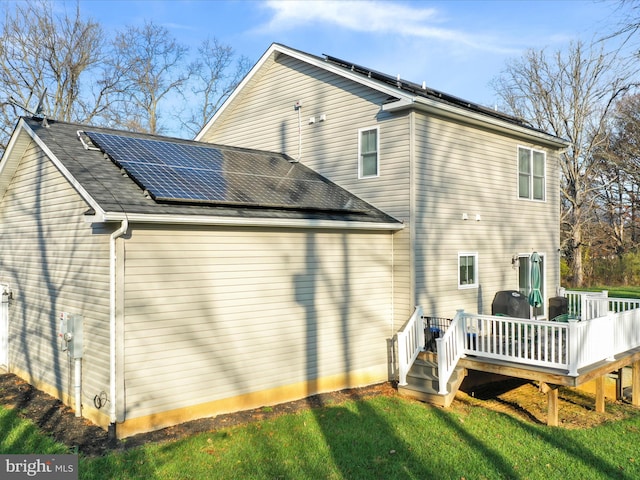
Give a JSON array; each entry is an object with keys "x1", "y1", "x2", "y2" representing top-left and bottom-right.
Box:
[{"x1": 414, "y1": 114, "x2": 560, "y2": 317}]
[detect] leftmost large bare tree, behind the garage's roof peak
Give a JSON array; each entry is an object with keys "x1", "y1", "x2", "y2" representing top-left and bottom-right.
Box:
[{"x1": 0, "y1": 0, "x2": 109, "y2": 149}]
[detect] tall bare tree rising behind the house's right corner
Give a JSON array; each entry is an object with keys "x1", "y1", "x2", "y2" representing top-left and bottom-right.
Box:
[{"x1": 493, "y1": 43, "x2": 635, "y2": 286}]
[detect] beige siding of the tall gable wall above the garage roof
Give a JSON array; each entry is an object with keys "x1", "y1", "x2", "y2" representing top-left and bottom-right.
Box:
[{"x1": 202, "y1": 55, "x2": 414, "y2": 326}]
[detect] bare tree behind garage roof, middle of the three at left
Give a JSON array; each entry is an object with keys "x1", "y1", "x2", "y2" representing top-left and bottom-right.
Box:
[{"x1": 109, "y1": 22, "x2": 191, "y2": 134}]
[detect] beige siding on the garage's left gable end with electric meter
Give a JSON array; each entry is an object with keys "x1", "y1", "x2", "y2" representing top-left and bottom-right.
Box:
[{"x1": 0, "y1": 145, "x2": 109, "y2": 405}]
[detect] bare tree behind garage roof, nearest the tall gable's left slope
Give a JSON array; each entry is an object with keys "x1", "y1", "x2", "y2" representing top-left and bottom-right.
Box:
[{"x1": 184, "y1": 38, "x2": 251, "y2": 135}]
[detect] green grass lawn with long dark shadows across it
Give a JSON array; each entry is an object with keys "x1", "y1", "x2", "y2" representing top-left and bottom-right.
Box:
[{"x1": 0, "y1": 397, "x2": 640, "y2": 480}]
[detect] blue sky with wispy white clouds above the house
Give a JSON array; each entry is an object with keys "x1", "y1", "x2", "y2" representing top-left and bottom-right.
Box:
[{"x1": 75, "y1": 0, "x2": 624, "y2": 106}]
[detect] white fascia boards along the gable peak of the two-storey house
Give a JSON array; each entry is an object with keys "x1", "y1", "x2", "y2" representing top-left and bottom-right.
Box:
[{"x1": 195, "y1": 43, "x2": 414, "y2": 141}]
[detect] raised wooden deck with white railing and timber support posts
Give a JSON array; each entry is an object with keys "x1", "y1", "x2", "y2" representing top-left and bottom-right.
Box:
[{"x1": 397, "y1": 292, "x2": 640, "y2": 425}]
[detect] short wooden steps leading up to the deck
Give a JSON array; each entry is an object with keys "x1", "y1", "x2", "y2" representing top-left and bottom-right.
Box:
[{"x1": 398, "y1": 352, "x2": 467, "y2": 408}]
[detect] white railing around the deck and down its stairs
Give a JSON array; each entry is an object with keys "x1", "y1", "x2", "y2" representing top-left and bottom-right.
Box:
[{"x1": 397, "y1": 291, "x2": 640, "y2": 395}]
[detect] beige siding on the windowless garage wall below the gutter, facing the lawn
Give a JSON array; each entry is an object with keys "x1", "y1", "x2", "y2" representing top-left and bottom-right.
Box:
[{"x1": 119, "y1": 226, "x2": 393, "y2": 418}]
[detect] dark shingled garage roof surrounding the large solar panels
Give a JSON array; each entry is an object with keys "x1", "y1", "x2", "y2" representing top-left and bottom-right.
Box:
[{"x1": 24, "y1": 117, "x2": 401, "y2": 226}]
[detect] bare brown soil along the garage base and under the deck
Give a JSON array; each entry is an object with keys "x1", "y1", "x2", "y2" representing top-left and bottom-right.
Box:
[{"x1": 0, "y1": 374, "x2": 636, "y2": 456}]
